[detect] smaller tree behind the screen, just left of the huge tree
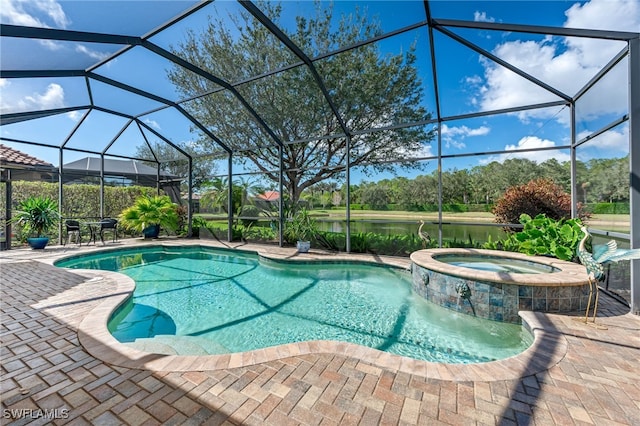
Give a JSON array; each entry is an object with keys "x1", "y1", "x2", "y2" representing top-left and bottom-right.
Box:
[{"x1": 136, "y1": 143, "x2": 216, "y2": 190}]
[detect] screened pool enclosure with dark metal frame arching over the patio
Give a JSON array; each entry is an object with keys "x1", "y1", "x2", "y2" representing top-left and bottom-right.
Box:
[{"x1": 0, "y1": 0, "x2": 640, "y2": 314}]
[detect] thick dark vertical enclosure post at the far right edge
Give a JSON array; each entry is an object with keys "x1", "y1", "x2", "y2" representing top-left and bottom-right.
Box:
[{"x1": 629, "y1": 37, "x2": 640, "y2": 315}]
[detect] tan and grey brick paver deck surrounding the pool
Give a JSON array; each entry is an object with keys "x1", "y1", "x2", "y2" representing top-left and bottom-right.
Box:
[{"x1": 0, "y1": 240, "x2": 640, "y2": 426}]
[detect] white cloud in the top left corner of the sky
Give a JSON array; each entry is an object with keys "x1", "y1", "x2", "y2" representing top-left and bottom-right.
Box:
[{"x1": 0, "y1": 0, "x2": 71, "y2": 28}]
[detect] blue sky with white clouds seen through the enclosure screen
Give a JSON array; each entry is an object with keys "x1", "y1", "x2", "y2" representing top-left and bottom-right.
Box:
[{"x1": 0, "y1": 0, "x2": 640, "y2": 185}]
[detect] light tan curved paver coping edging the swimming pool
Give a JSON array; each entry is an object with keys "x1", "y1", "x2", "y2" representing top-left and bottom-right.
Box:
[{"x1": 73, "y1": 242, "x2": 568, "y2": 381}]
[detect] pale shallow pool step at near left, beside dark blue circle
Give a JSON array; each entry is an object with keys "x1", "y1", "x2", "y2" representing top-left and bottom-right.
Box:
[{"x1": 126, "y1": 334, "x2": 230, "y2": 355}]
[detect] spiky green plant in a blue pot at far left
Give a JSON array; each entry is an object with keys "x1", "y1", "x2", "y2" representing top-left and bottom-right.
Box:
[{"x1": 11, "y1": 197, "x2": 60, "y2": 249}]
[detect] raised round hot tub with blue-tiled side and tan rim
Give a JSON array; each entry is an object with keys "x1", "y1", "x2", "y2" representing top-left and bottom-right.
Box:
[{"x1": 411, "y1": 248, "x2": 589, "y2": 323}]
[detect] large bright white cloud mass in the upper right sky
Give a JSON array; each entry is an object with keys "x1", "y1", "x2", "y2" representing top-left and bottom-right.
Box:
[{"x1": 471, "y1": 0, "x2": 640, "y2": 124}]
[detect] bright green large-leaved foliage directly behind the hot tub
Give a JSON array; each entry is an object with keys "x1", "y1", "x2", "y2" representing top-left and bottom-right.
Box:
[{"x1": 483, "y1": 214, "x2": 583, "y2": 261}]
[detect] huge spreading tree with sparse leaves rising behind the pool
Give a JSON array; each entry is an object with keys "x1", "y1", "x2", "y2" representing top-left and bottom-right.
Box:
[{"x1": 169, "y1": 2, "x2": 433, "y2": 206}]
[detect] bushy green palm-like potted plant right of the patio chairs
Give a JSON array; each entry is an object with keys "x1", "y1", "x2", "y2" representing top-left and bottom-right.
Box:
[{"x1": 119, "y1": 195, "x2": 178, "y2": 238}]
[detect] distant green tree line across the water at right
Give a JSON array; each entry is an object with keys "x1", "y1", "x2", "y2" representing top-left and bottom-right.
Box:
[{"x1": 303, "y1": 156, "x2": 629, "y2": 210}]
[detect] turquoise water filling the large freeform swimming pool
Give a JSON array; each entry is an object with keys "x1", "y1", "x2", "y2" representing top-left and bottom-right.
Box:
[{"x1": 56, "y1": 247, "x2": 532, "y2": 363}]
